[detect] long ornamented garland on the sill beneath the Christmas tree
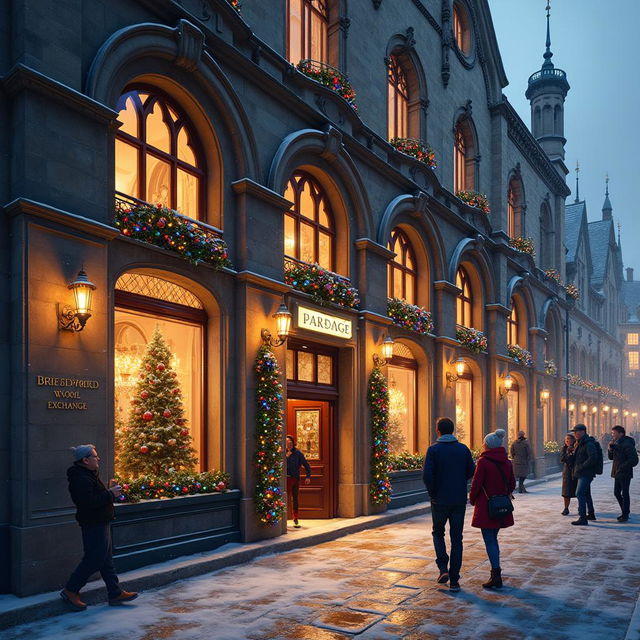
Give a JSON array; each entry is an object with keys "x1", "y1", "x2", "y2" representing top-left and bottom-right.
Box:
[{"x1": 116, "y1": 471, "x2": 230, "y2": 502}]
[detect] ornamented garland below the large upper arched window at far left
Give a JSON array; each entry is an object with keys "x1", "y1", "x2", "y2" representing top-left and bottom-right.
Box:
[{"x1": 115, "y1": 204, "x2": 231, "y2": 269}]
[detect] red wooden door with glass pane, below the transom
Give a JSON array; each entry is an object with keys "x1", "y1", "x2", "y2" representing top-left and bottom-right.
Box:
[{"x1": 287, "y1": 400, "x2": 335, "y2": 518}]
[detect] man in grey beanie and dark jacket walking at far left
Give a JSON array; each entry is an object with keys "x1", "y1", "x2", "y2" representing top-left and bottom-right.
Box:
[{"x1": 60, "y1": 444, "x2": 138, "y2": 611}]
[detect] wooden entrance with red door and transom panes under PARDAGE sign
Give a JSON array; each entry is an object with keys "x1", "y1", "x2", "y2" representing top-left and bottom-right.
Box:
[{"x1": 287, "y1": 343, "x2": 338, "y2": 519}]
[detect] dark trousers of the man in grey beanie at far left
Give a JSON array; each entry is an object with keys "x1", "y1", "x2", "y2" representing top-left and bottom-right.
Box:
[{"x1": 66, "y1": 523, "x2": 122, "y2": 598}]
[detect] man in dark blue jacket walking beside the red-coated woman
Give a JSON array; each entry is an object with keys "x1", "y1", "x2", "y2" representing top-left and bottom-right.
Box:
[{"x1": 422, "y1": 418, "x2": 475, "y2": 591}]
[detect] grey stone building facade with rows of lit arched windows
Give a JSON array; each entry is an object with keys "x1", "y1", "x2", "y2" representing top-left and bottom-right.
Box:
[{"x1": 0, "y1": 0, "x2": 632, "y2": 595}]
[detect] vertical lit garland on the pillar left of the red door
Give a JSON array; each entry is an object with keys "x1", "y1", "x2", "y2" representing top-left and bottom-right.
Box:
[{"x1": 255, "y1": 345, "x2": 285, "y2": 525}]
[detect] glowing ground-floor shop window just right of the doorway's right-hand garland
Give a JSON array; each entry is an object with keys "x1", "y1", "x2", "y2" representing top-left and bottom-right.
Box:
[{"x1": 387, "y1": 342, "x2": 418, "y2": 455}]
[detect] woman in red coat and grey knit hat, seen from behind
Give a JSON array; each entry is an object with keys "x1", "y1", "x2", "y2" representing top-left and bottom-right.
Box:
[{"x1": 469, "y1": 429, "x2": 516, "y2": 589}]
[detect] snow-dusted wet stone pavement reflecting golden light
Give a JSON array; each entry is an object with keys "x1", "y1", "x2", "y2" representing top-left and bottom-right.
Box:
[{"x1": 5, "y1": 467, "x2": 640, "y2": 640}]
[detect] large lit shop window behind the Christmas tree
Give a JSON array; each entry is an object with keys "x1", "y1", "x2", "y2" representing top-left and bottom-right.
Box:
[{"x1": 114, "y1": 274, "x2": 206, "y2": 469}]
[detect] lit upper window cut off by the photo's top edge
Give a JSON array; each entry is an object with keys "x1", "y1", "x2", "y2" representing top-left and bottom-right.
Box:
[{"x1": 287, "y1": 0, "x2": 329, "y2": 64}]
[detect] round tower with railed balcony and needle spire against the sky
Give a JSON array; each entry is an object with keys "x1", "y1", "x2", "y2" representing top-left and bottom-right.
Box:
[{"x1": 525, "y1": 0, "x2": 570, "y2": 178}]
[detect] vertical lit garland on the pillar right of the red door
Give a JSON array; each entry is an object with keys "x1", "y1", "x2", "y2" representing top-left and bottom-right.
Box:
[{"x1": 367, "y1": 364, "x2": 391, "y2": 504}]
